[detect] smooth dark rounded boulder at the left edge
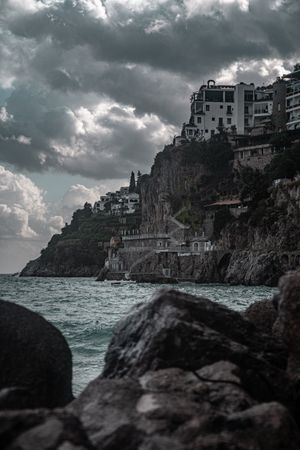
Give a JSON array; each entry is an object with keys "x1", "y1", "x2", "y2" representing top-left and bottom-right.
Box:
[{"x1": 0, "y1": 300, "x2": 73, "y2": 409}]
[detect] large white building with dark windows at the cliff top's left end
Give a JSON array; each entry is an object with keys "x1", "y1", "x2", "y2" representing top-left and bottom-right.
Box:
[{"x1": 183, "y1": 80, "x2": 255, "y2": 140}]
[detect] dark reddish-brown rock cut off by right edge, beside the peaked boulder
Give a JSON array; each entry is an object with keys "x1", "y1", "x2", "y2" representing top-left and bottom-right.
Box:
[{"x1": 278, "y1": 271, "x2": 300, "y2": 381}]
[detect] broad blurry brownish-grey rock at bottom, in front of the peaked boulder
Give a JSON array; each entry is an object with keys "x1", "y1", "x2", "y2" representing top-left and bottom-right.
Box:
[{"x1": 69, "y1": 361, "x2": 300, "y2": 450}]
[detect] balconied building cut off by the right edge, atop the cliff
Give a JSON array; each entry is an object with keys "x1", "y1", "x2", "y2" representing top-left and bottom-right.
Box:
[{"x1": 284, "y1": 64, "x2": 300, "y2": 130}]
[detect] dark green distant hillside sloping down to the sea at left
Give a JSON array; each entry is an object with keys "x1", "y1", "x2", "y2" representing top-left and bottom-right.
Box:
[{"x1": 20, "y1": 203, "x2": 140, "y2": 277}]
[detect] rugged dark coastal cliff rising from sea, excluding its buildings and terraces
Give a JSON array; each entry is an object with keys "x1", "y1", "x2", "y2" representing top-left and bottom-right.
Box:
[{"x1": 127, "y1": 141, "x2": 300, "y2": 286}]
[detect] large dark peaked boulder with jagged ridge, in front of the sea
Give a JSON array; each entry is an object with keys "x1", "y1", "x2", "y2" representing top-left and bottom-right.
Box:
[{"x1": 103, "y1": 290, "x2": 290, "y2": 408}]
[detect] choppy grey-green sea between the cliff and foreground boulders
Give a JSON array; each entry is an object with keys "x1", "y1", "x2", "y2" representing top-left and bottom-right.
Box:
[{"x1": 0, "y1": 275, "x2": 276, "y2": 395}]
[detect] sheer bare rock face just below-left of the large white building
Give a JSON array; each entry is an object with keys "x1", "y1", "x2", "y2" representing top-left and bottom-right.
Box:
[{"x1": 141, "y1": 144, "x2": 226, "y2": 232}]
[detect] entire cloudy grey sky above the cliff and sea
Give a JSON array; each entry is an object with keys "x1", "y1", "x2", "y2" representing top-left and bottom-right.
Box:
[{"x1": 0, "y1": 0, "x2": 300, "y2": 273}]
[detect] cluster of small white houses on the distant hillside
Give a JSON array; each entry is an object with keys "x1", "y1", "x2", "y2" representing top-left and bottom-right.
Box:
[{"x1": 93, "y1": 186, "x2": 140, "y2": 216}]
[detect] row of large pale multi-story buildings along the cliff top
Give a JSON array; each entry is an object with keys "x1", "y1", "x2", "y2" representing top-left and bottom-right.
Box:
[{"x1": 174, "y1": 64, "x2": 300, "y2": 145}]
